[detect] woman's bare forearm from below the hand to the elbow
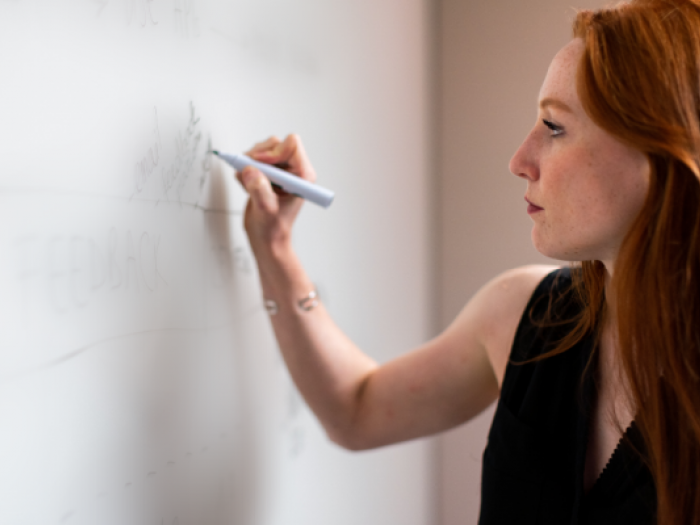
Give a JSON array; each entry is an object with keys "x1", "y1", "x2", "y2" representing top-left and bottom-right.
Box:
[{"x1": 254, "y1": 239, "x2": 377, "y2": 446}]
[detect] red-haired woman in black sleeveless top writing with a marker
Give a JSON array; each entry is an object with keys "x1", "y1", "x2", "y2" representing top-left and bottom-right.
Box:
[{"x1": 238, "y1": 0, "x2": 700, "y2": 524}]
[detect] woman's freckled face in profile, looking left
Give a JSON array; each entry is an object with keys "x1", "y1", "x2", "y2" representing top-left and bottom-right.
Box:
[{"x1": 510, "y1": 39, "x2": 650, "y2": 271}]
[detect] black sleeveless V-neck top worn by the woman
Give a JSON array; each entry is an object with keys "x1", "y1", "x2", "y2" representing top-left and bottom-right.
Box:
[{"x1": 479, "y1": 269, "x2": 656, "y2": 525}]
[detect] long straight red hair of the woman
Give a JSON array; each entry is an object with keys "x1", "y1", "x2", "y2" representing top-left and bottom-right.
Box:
[{"x1": 549, "y1": 0, "x2": 700, "y2": 525}]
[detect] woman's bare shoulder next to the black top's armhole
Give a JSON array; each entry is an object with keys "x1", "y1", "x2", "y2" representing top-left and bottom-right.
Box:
[{"x1": 465, "y1": 265, "x2": 560, "y2": 388}]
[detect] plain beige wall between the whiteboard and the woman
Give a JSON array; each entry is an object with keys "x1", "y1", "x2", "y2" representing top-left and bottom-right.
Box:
[{"x1": 438, "y1": 0, "x2": 603, "y2": 525}]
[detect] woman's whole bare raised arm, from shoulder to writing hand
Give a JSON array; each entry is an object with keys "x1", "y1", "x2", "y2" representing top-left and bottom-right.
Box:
[{"x1": 237, "y1": 135, "x2": 553, "y2": 450}]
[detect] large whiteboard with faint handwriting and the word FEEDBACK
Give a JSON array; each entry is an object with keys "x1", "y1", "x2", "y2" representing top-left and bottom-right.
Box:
[{"x1": 0, "y1": 0, "x2": 434, "y2": 525}]
